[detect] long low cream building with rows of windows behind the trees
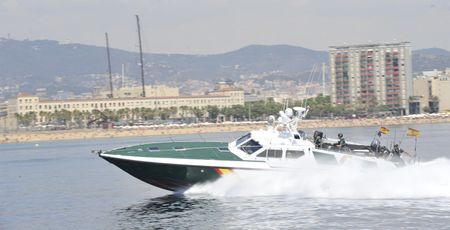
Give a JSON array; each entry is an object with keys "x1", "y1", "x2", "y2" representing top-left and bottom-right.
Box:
[{"x1": 6, "y1": 86, "x2": 244, "y2": 128}]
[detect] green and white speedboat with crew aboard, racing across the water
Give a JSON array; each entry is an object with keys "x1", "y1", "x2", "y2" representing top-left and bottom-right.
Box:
[{"x1": 97, "y1": 107, "x2": 412, "y2": 193}]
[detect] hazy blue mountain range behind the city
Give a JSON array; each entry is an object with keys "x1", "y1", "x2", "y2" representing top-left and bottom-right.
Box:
[{"x1": 0, "y1": 38, "x2": 450, "y2": 97}]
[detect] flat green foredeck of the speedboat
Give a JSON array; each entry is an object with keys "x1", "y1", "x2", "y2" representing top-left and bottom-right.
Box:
[{"x1": 106, "y1": 142, "x2": 242, "y2": 161}]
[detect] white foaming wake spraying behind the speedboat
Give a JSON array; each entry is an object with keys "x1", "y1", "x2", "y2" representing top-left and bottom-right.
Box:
[{"x1": 186, "y1": 158, "x2": 450, "y2": 199}]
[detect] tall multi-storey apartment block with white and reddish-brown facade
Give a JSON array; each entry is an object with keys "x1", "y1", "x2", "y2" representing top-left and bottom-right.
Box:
[{"x1": 329, "y1": 42, "x2": 412, "y2": 114}]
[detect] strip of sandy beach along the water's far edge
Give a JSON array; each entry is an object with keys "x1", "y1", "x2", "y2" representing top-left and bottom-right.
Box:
[{"x1": 0, "y1": 114, "x2": 450, "y2": 144}]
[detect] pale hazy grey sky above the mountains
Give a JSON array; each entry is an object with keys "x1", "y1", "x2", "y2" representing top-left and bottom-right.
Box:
[{"x1": 0, "y1": 0, "x2": 450, "y2": 54}]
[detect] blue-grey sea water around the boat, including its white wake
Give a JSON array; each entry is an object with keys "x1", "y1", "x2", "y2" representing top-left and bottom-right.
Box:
[{"x1": 0, "y1": 124, "x2": 450, "y2": 229}]
